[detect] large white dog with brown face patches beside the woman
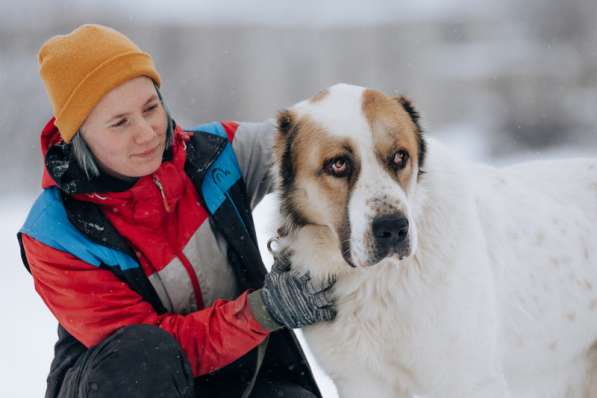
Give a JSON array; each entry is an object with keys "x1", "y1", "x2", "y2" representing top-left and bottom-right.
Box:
[{"x1": 274, "y1": 84, "x2": 597, "y2": 398}]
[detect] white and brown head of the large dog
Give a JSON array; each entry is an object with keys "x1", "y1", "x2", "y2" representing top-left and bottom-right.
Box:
[{"x1": 274, "y1": 84, "x2": 425, "y2": 267}]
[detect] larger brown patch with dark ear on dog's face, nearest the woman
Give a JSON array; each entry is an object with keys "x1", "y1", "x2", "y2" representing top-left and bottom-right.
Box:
[{"x1": 274, "y1": 111, "x2": 360, "y2": 243}]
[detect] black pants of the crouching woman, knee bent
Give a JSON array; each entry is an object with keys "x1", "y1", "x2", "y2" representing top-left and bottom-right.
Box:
[{"x1": 58, "y1": 325, "x2": 315, "y2": 398}]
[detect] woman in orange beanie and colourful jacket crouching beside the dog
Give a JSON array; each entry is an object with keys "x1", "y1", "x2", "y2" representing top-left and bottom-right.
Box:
[{"x1": 18, "y1": 25, "x2": 335, "y2": 397}]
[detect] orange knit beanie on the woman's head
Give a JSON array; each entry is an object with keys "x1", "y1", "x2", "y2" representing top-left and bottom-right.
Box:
[{"x1": 38, "y1": 25, "x2": 160, "y2": 142}]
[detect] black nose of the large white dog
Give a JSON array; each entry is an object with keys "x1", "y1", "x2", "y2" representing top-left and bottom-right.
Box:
[{"x1": 371, "y1": 213, "x2": 408, "y2": 257}]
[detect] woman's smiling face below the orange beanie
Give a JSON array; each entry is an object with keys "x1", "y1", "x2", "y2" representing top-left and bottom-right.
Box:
[{"x1": 81, "y1": 76, "x2": 167, "y2": 178}]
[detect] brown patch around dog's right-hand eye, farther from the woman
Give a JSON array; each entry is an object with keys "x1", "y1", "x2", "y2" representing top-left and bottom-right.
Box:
[{"x1": 363, "y1": 89, "x2": 424, "y2": 192}]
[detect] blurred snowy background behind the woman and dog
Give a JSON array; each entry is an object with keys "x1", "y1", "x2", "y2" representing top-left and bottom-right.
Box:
[{"x1": 0, "y1": 0, "x2": 597, "y2": 397}]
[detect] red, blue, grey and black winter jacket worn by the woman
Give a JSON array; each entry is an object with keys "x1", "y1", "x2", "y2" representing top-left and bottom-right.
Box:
[{"x1": 19, "y1": 120, "x2": 319, "y2": 396}]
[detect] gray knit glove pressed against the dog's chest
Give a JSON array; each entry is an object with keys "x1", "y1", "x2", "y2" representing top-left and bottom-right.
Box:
[{"x1": 254, "y1": 253, "x2": 336, "y2": 328}]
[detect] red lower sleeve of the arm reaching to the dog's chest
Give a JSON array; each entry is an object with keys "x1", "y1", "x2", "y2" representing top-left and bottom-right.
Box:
[{"x1": 23, "y1": 235, "x2": 268, "y2": 376}]
